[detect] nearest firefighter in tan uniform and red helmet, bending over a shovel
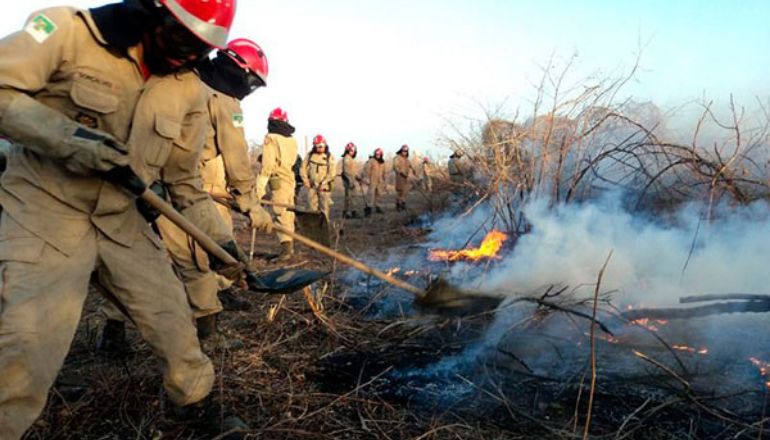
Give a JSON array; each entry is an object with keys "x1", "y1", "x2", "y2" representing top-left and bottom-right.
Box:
[{"x1": 0, "y1": 0, "x2": 268, "y2": 440}]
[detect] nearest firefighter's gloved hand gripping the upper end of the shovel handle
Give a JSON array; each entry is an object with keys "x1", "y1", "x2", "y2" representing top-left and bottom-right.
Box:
[{"x1": 64, "y1": 128, "x2": 128, "y2": 174}]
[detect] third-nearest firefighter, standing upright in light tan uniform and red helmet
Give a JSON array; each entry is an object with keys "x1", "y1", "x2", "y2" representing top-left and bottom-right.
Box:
[{"x1": 257, "y1": 108, "x2": 297, "y2": 262}]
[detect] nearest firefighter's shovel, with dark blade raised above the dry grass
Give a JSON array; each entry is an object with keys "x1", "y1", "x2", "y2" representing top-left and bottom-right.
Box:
[{"x1": 139, "y1": 189, "x2": 329, "y2": 294}]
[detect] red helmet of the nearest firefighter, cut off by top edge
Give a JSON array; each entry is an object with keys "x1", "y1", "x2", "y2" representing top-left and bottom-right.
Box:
[{"x1": 159, "y1": 0, "x2": 236, "y2": 49}]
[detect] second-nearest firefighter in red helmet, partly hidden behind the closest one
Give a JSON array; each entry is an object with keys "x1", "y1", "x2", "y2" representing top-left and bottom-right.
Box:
[{"x1": 97, "y1": 39, "x2": 268, "y2": 344}]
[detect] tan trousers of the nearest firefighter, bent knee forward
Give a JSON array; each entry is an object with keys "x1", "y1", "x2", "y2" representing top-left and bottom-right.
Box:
[{"x1": 0, "y1": 213, "x2": 214, "y2": 440}]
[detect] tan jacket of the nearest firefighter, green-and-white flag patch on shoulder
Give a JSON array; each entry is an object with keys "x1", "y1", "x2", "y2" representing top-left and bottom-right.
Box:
[{"x1": 0, "y1": 8, "x2": 231, "y2": 254}]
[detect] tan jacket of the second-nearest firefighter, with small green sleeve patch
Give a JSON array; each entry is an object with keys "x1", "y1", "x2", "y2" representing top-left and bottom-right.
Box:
[{"x1": 202, "y1": 85, "x2": 254, "y2": 207}]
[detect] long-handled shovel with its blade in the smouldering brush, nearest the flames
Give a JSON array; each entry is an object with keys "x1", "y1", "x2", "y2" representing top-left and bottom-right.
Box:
[{"x1": 273, "y1": 225, "x2": 503, "y2": 315}]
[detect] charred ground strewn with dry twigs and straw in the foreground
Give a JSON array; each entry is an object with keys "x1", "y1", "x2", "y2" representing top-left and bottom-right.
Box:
[{"x1": 21, "y1": 186, "x2": 767, "y2": 439}]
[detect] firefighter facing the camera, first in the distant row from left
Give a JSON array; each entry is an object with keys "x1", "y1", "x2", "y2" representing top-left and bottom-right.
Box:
[{"x1": 302, "y1": 134, "x2": 336, "y2": 218}]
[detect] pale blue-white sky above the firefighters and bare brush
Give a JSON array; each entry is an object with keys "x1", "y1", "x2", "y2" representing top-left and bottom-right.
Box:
[{"x1": 0, "y1": 0, "x2": 770, "y2": 155}]
